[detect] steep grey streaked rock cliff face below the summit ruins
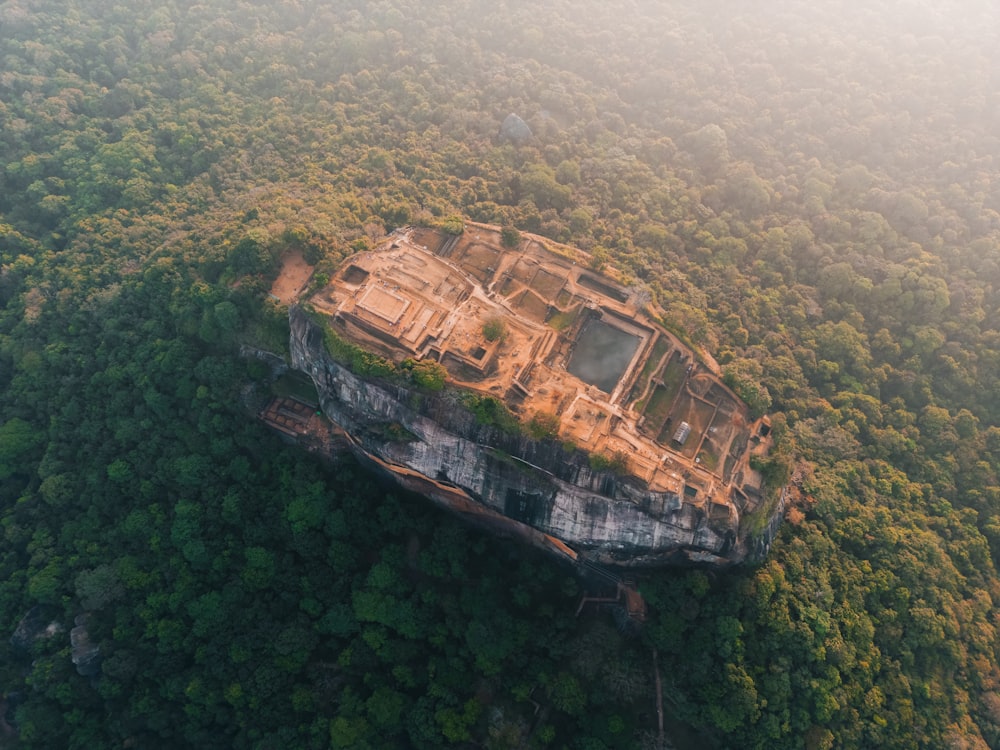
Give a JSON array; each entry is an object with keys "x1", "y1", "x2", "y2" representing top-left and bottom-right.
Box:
[{"x1": 289, "y1": 306, "x2": 782, "y2": 565}]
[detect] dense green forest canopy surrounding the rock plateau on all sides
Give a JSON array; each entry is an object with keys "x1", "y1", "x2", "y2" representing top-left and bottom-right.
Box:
[{"x1": 0, "y1": 0, "x2": 1000, "y2": 749}]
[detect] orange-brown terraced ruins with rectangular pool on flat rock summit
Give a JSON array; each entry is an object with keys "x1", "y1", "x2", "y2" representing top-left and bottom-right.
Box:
[{"x1": 309, "y1": 222, "x2": 769, "y2": 512}]
